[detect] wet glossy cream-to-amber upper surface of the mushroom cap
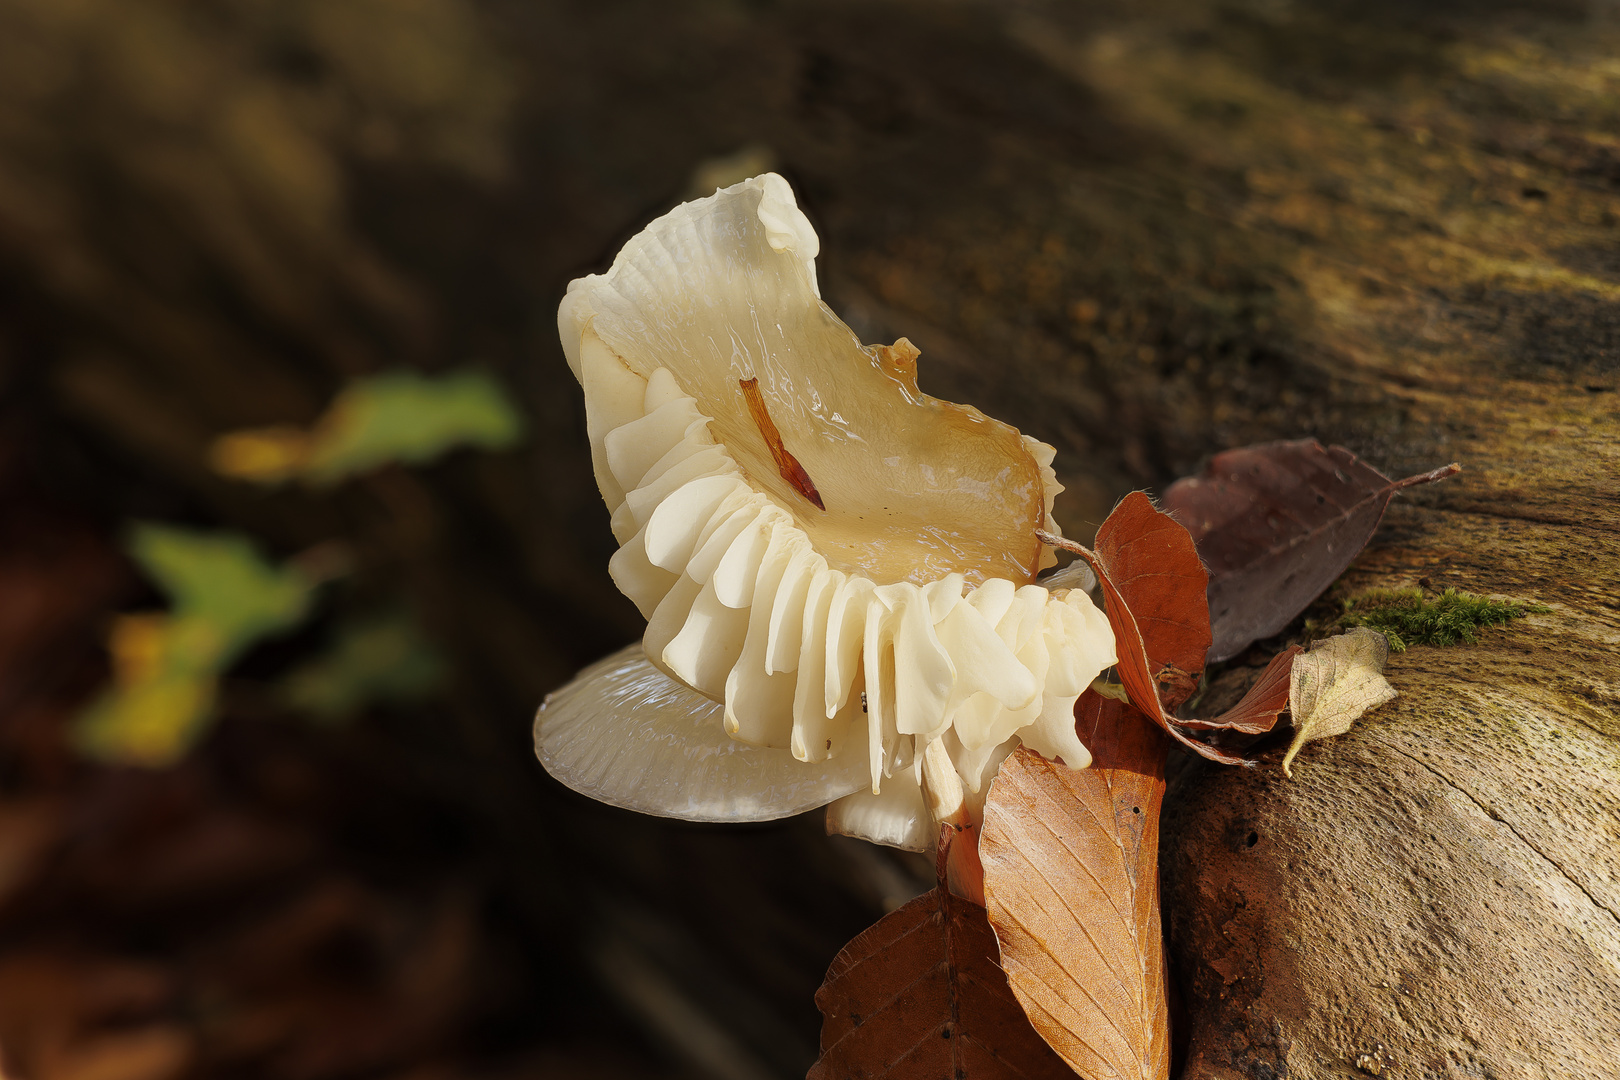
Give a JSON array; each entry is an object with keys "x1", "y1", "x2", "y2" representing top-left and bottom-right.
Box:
[{"x1": 576, "y1": 189, "x2": 1043, "y2": 585}]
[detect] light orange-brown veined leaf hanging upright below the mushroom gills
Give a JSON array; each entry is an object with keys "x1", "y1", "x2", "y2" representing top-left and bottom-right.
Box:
[{"x1": 978, "y1": 691, "x2": 1170, "y2": 1080}]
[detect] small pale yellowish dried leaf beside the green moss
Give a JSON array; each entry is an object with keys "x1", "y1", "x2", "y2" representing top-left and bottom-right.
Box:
[{"x1": 1283, "y1": 627, "x2": 1395, "y2": 776}]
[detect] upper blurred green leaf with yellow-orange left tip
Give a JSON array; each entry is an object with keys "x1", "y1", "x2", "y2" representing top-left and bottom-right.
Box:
[{"x1": 211, "y1": 371, "x2": 523, "y2": 484}]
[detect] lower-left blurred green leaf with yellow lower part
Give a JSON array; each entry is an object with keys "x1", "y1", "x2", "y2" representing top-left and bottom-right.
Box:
[{"x1": 75, "y1": 525, "x2": 316, "y2": 766}]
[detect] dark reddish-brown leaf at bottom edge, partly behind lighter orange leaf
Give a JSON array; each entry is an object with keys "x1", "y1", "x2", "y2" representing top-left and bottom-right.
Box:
[{"x1": 807, "y1": 889, "x2": 1074, "y2": 1080}]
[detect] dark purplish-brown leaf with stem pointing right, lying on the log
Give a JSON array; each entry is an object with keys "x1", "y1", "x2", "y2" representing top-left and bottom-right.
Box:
[{"x1": 1160, "y1": 439, "x2": 1460, "y2": 664}]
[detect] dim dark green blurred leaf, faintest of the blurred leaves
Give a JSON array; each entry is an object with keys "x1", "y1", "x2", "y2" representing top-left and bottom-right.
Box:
[{"x1": 282, "y1": 614, "x2": 447, "y2": 721}]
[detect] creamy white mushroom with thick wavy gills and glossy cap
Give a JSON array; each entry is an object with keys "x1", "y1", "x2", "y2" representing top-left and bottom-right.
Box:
[{"x1": 535, "y1": 173, "x2": 1115, "y2": 848}]
